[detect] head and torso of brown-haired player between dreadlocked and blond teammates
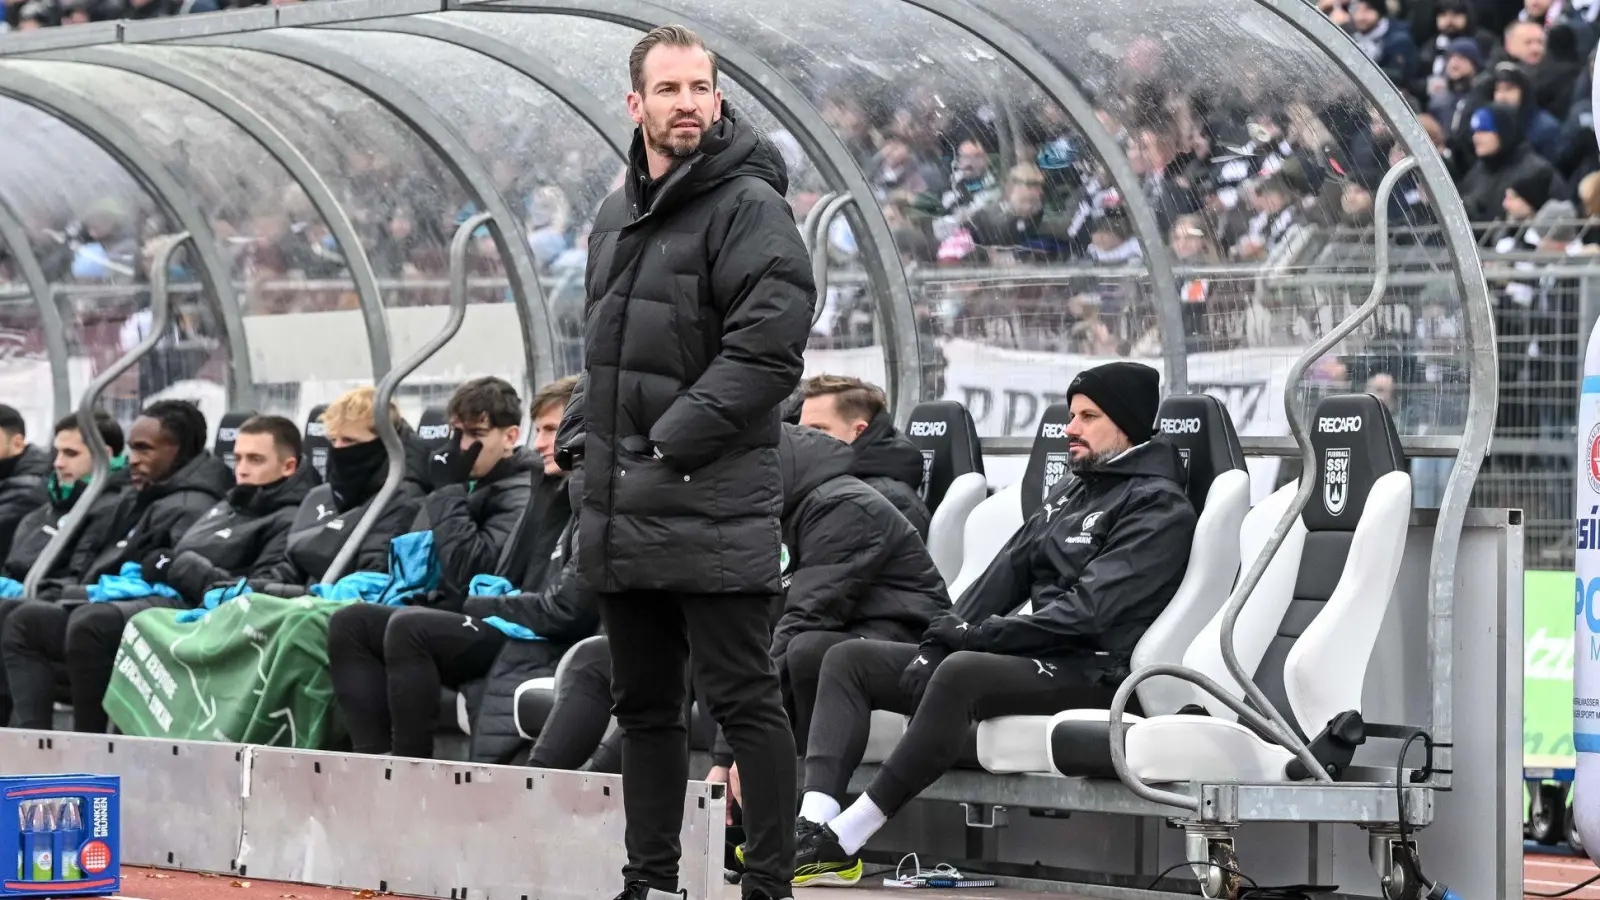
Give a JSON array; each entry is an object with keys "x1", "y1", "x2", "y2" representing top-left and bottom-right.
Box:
[{"x1": 144, "y1": 416, "x2": 322, "y2": 605}]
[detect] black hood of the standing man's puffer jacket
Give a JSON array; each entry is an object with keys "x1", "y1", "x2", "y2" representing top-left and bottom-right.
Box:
[{"x1": 627, "y1": 101, "x2": 789, "y2": 218}]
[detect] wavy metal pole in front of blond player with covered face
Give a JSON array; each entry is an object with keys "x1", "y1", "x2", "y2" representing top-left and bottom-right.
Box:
[{"x1": 322, "y1": 213, "x2": 483, "y2": 585}]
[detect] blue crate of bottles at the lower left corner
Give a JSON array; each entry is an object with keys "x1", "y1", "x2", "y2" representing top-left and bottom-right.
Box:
[{"x1": 0, "y1": 775, "x2": 122, "y2": 897}]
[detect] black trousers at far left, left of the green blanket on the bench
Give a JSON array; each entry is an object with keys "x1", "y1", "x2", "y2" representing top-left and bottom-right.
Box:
[{"x1": 0, "y1": 596, "x2": 181, "y2": 733}]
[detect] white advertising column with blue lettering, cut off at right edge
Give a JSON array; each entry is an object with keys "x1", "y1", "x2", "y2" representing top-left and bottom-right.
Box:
[{"x1": 1573, "y1": 277, "x2": 1600, "y2": 858}]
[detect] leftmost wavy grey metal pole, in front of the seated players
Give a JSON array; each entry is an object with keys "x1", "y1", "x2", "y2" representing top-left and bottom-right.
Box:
[{"x1": 22, "y1": 232, "x2": 190, "y2": 599}]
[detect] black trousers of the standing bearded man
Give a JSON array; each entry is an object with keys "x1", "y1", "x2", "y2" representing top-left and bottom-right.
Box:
[{"x1": 600, "y1": 591, "x2": 795, "y2": 898}]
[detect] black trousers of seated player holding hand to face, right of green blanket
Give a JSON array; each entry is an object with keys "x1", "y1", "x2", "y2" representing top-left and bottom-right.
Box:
[{"x1": 328, "y1": 604, "x2": 507, "y2": 759}]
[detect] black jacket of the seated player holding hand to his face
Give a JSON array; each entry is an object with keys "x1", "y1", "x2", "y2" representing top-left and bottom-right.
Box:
[{"x1": 413, "y1": 450, "x2": 533, "y2": 609}]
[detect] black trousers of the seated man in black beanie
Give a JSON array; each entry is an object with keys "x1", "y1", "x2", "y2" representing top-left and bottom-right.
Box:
[{"x1": 805, "y1": 641, "x2": 1117, "y2": 815}]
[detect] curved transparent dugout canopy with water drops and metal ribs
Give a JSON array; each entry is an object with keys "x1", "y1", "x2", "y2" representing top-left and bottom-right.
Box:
[{"x1": 0, "y1": 0, "x2": 1493, "y2": 455}]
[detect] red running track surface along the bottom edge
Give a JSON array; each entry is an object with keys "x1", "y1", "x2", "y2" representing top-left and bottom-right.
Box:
[{"x1": 78, "y1": 854, "x2": 1600, "y2": 900}]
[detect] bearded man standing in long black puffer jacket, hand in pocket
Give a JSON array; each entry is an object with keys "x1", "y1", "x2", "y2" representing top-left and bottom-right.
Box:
[{"x1": 560, "y1": 26, "x2": 816, "y2": 900}]
